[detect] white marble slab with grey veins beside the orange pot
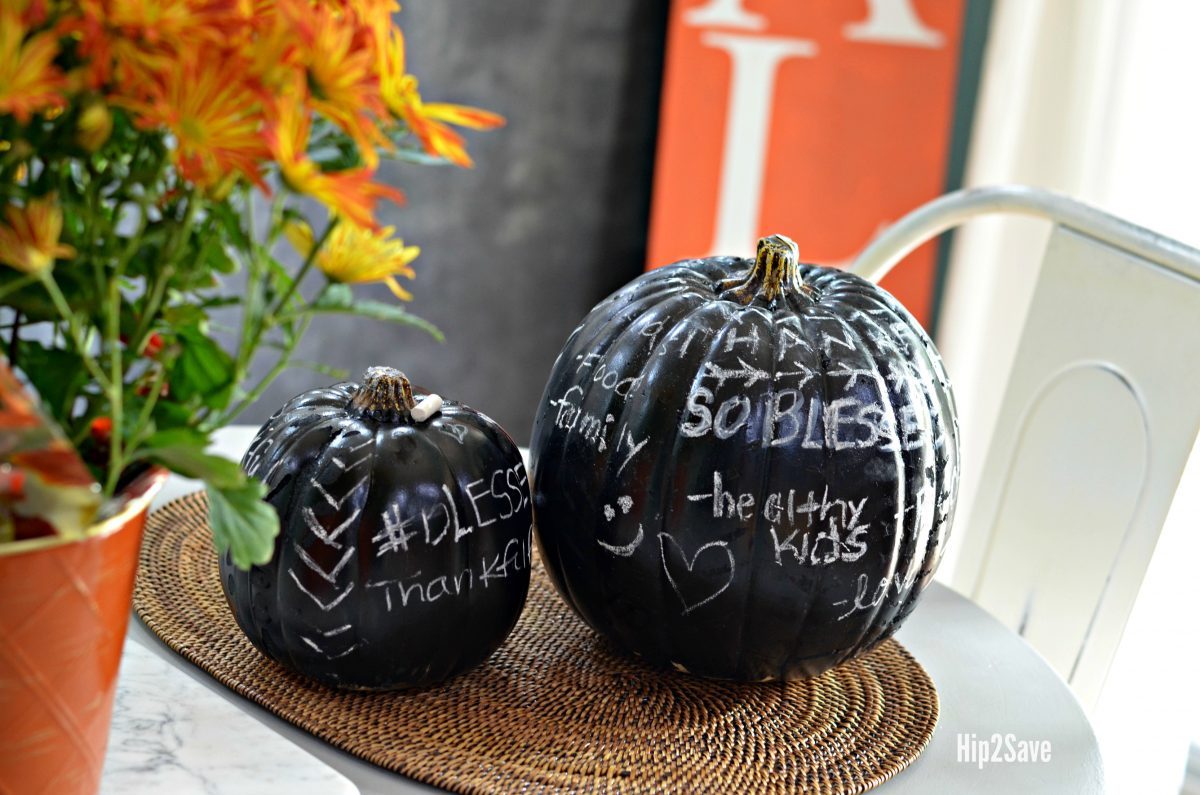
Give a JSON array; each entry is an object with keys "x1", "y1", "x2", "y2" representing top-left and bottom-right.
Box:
[{"x1": 100, "y1": 638, "x2": 359, "y2": 795}]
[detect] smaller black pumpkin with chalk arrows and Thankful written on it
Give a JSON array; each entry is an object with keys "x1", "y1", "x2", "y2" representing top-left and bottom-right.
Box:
[{"x1": 221, "y1": 367, "x2": 532, "y2": 689}]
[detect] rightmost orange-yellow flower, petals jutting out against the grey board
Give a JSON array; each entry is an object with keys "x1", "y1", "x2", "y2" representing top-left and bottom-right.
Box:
[{"x1": 380, "y1": 30, "x2": 504, "y2": 168}]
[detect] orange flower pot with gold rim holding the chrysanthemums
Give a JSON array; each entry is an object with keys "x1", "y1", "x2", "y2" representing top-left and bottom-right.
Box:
[{"x1": 0, "y1": 470, "x2": 167, "y2": 795}]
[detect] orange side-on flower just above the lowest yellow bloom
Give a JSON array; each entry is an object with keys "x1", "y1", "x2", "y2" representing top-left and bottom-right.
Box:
[{"x1": 266, "y1": 100, "x2": 404, "y2": 228}]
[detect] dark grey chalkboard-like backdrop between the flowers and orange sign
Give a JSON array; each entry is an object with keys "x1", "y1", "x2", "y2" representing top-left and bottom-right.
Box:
[{"x1": 239, "y1": 0, "x2": 667, "y2": 444}]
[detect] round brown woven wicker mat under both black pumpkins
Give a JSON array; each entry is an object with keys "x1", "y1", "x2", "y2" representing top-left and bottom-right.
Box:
[{"x1": 134, "y1": 494, "x2": 937, "y2": 794}]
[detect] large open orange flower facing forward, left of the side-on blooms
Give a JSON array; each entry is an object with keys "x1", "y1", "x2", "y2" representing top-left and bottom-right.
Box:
[{"x1": 113, "y1": 50, "x2": 270, "y2": 191}]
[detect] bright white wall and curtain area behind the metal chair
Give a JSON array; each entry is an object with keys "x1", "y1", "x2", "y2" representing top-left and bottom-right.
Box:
[{"x1": 938, "y1": 0, "x2": 1200, "y2": 793}]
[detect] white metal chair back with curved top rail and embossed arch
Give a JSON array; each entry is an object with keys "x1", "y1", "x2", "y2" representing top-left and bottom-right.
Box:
[{"x1": 853, "y1": 187, "x2": 1200, "y2": 707}]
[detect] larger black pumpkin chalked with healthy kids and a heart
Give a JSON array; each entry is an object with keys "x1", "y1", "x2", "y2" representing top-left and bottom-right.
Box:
[{"x1": 530, "y1": 237, "x2": 959, "y2": 681}]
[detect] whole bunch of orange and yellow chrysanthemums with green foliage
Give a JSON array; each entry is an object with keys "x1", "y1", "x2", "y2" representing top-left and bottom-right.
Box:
[{"x1": 0, "y1": 0, "x2": 502, "y2": 566}]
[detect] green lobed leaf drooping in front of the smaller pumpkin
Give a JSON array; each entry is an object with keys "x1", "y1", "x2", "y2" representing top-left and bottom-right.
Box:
[{"x1": 208, "y1": 479, "x2": 280, "y2": 569}]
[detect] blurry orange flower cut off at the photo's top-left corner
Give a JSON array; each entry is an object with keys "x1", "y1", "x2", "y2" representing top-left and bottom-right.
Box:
[{"x1": 0, "y1": 8, "x2": 66, "y2": 124}]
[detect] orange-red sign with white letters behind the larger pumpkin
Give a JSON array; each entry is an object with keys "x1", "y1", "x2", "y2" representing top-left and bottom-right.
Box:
[{"x1": 648, "y1": 0, "x2": 966, "y2": 325}]
